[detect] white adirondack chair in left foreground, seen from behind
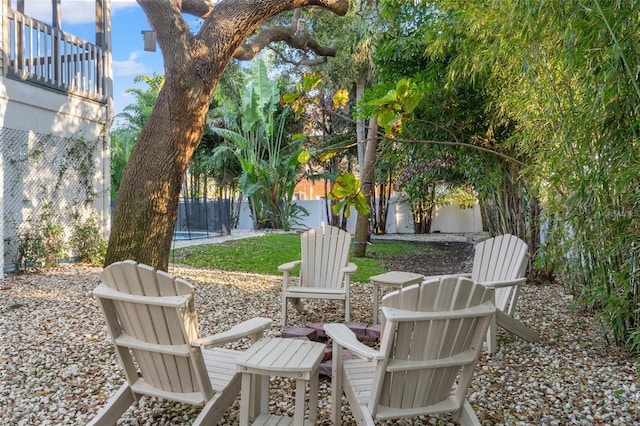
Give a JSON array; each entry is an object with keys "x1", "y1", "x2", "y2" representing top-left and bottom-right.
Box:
[{"x1": 90, "y1": 260, "x2": 272, "y2": 425}]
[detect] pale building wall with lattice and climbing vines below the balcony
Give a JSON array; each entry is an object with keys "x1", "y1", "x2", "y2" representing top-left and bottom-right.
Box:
[{"x1": 0, "y1": 77, "x2": 110, "y2": 268}]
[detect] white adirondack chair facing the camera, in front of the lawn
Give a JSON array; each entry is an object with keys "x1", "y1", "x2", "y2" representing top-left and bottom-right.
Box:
[{"x1": 278, "y1": 226, "x2": 357, "y2": 327}]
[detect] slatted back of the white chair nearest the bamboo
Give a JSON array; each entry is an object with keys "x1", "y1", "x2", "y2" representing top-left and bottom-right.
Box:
[{"x1": 471, "y1": 234, "x2": 529, "y2": 315}]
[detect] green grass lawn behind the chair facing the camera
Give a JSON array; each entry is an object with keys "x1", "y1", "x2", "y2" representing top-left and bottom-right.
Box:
[{"x1": 170, "y1": 234, "x2": 424, "y2": 282}]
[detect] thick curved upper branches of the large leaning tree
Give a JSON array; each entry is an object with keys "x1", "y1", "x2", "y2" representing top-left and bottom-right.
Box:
[{"x1": 137, "y1": 0, "x2": 349, "y2": 82}]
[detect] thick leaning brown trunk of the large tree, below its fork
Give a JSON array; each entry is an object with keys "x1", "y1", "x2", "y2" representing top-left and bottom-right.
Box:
[{"x1": 105, "y1": 83, "x2": 210, "y2": 270}]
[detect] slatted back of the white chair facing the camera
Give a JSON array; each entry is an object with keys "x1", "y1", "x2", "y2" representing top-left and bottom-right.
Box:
[{"x1": 300, "y1": 226, "x2": 351, "y2": 289}]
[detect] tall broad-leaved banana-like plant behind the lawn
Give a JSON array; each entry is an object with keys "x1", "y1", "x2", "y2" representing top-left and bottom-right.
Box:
[{"x1": 211, "y1": 61, "x2": 306, "y2": 230}]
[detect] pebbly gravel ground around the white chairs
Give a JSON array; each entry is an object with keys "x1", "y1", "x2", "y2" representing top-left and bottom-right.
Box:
[{"x1": 0, "y1": 235, "x2": 640, "y2": 425}]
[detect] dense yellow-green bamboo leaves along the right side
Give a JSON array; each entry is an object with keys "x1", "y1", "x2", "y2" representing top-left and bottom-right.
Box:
[{"x1": 442, "y1": 0, "x2": 640, "y2": 351}]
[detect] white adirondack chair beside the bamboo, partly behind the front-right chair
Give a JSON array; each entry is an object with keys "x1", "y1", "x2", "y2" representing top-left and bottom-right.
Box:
[{"x1": 426, "y1": 234, "x2": 538, "y2": 353}]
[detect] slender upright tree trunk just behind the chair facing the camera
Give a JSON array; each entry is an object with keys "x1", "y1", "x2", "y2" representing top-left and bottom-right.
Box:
[{"x1": 353, "y1": 115, "x2": 378, "y2": 257}]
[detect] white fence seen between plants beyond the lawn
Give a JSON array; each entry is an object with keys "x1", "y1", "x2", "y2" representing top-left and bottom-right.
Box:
[{"x1": 237, "y1": 198, "x2": 482, "y2": 234}]
